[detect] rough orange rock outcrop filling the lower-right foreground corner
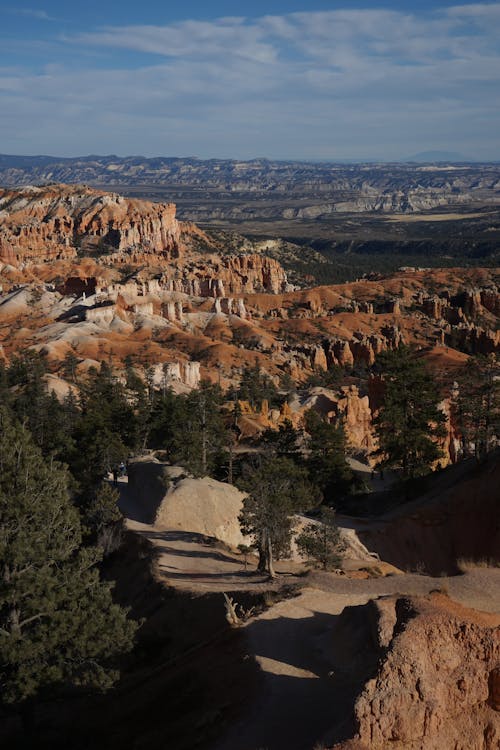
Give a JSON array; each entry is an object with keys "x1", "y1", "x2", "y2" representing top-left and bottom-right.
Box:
[{"x1": 335, "y1": 593, "x2": 500, "y2": 750}]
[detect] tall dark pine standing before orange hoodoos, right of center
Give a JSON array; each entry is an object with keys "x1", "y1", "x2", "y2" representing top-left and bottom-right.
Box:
[{"x1": 374, "y1": 346, "x2": 445, "y2": 479}]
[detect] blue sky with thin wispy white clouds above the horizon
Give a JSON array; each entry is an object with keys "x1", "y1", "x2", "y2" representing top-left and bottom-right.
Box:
[{"x1": 0, "y1": 0, "x2": 500, "y2": 160}]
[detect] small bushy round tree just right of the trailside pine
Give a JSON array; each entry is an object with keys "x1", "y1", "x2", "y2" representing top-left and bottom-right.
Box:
[{"x1": 296, "y1": 506, "x2": 344, "y2": 570}]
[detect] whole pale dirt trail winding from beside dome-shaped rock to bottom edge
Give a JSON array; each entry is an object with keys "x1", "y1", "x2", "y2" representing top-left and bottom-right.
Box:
[{"x1": 120, "y1": 481, "x2": 500, "y2": 750}]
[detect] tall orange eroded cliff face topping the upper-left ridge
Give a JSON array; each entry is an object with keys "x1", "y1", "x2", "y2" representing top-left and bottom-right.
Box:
[{"x1": 0, "y1": 185, "x2": 181, "y2": 264}]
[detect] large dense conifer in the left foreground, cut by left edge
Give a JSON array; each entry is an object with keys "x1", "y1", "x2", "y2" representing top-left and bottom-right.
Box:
[{"x1": 0, "y1": 409, "x2": 136, "y2": 704}]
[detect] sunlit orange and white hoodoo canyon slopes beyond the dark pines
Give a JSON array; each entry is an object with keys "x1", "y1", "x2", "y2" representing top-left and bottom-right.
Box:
[{"x1": 0, "y1": 185, "x2": 500, "y2": 461}]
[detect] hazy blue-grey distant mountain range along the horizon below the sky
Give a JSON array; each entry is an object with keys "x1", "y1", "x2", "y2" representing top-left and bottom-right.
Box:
[{"x1": 0, "y1": 151, "x2": 500, "y2": 222}]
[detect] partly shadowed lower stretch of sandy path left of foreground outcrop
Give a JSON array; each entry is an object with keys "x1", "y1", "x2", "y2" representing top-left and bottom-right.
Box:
[{"x1": 211, "y1": 589, "x2": 369, "y2": 750}]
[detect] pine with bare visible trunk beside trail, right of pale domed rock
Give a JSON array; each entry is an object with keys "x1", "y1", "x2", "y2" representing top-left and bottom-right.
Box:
[{"x1": 238, "y1": 456, "x2": 318, "y2": 576}]
